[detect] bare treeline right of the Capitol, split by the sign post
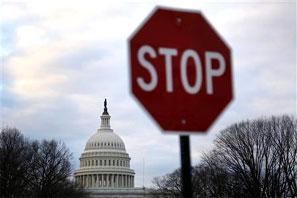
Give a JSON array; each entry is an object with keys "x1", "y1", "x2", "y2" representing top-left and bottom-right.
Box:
[{"x1": 153, "y1": 116, "x2": 297, "y2": 198}]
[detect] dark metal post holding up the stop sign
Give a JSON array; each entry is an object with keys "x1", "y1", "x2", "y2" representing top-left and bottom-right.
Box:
[{"x1": 179, "y1": 135, "x2": 192, "y2": 198}]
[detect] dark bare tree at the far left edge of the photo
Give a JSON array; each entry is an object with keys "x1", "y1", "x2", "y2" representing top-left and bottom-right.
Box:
[{"x1": 0, "y1": 127, "x2": 30, "y2": 197}]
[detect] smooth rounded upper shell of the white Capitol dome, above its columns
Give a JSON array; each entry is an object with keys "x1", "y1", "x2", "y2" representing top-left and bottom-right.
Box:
[{"x1": 85, "y1": 130, "x2": 126, "y2": 151}]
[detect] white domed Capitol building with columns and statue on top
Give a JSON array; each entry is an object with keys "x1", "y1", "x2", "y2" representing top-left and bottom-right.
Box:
[{"x1": 74, "y1": 99, "x2": 150, "y2": 197}]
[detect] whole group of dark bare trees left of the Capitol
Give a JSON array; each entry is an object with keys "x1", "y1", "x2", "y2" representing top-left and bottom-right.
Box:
[{"x1": 0, "y1": 128, "x2": 85, "y2": 198}]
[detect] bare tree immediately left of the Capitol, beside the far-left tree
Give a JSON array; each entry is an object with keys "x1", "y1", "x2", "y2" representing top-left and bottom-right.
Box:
[{"x1": 25, "y1": 140, "x2": 71, "y2": 197}]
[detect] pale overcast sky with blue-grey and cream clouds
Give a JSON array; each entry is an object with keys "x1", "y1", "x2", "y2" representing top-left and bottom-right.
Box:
[{"x1": 0, "y1": 0, "x2": 296, "y2": 186}]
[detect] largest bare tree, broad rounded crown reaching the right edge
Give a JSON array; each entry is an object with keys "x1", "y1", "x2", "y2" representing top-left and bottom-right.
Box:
[{"x1": 205, "y1": 116, "x2": 297, "y2": 197}]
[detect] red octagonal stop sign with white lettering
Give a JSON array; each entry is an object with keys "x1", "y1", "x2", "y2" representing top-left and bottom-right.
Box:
[{"x1": 128, "y1": 8, "x2": 233, "y2": 132}]
